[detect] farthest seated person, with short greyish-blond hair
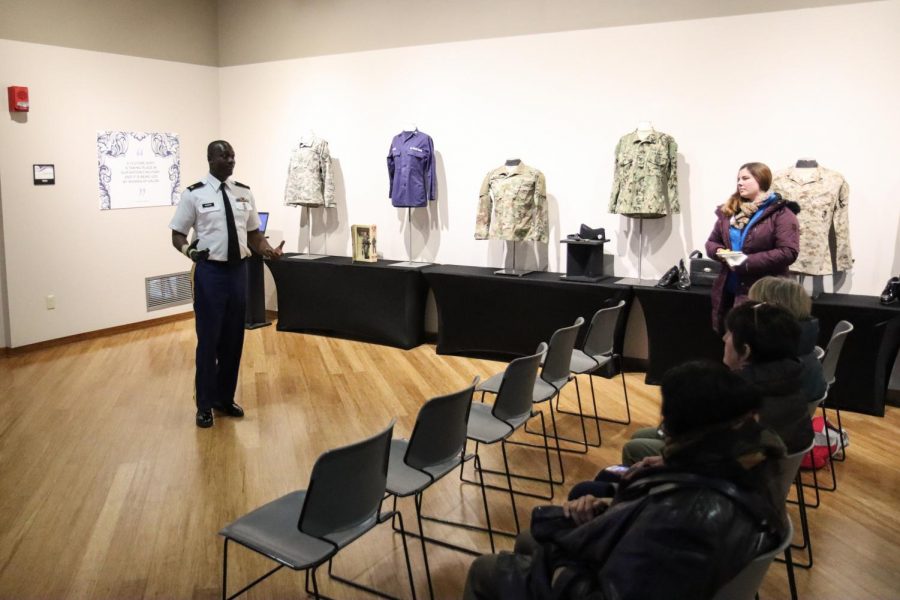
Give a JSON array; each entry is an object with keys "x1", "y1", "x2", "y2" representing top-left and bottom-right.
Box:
[{"x1": 748, "y1": 277, "x2": 828, "y2": 400}]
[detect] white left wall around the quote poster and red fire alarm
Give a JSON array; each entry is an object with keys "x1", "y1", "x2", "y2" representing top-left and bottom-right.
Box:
[{"x1": 0, "y1": 40, "x2": 219, "y2": 347}]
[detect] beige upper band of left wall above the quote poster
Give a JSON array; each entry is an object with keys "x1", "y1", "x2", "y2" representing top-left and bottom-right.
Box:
[{"x1": 0, "y1": 0, "x2": 217, "y2": 65}]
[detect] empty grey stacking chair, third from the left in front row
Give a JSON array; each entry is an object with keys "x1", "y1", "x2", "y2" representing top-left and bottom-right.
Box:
[{"x1": 460, "y1": 342, "x2": 553, "y2": 536}]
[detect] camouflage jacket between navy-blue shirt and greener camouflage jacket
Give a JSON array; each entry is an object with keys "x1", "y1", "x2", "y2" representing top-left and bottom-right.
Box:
[{"x1": 475, "y1": 163, "x2": 550, "y2": 243}]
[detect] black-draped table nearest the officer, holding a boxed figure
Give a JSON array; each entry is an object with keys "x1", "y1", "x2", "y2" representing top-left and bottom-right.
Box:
[{"x1": 266, "y1": 254, "x2": 428, "y2": 349}]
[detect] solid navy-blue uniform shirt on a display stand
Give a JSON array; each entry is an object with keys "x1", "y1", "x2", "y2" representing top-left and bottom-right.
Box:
[{"x1": 387, "y1": 129, "x2": 436, "y2": 208}]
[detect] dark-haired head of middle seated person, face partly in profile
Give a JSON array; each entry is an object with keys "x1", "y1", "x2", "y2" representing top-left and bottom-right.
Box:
[{"x1": 722, "y1": 301, "x2": 800, "y2": 370}]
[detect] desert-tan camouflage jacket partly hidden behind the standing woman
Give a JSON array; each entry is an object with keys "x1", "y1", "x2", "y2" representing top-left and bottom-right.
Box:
[{"x1": 772, "y1": 167, "x2": 853, "y2": 275}]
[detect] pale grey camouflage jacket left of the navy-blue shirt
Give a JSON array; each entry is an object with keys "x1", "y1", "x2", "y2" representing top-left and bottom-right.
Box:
[{"x1": 284, "y1": 137, "x2": 335, "y2": 207}]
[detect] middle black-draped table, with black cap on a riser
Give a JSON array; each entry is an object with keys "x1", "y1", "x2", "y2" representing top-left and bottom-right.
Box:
[{"x1": 423, "y1": 265, "x2": 631, "y2": 357}]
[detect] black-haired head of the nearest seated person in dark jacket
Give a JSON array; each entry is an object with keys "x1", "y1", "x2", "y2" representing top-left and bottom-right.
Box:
[{"x1": 661, "y1": 361, "x2": 761, "y2": 437}]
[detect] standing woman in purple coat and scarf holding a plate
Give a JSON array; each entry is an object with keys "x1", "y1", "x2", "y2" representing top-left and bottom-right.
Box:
[{"x1": 706, "y1": 163, "x2": 800, "y2": 333}]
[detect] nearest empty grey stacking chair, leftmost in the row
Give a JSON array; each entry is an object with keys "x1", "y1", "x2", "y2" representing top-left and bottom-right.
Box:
[{"x1": 219, "y1": 421, "x2": 416, "y2": 599}]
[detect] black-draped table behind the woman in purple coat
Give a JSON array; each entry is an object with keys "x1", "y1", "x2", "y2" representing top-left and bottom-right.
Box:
[{"x1": 635, "y1": 287, "x2": 900, "y2": 416}]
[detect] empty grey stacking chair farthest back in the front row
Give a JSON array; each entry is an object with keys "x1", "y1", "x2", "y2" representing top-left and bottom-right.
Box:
[{"x1": 556, "y1": 300, "x2": 631, "y2": 447}]
